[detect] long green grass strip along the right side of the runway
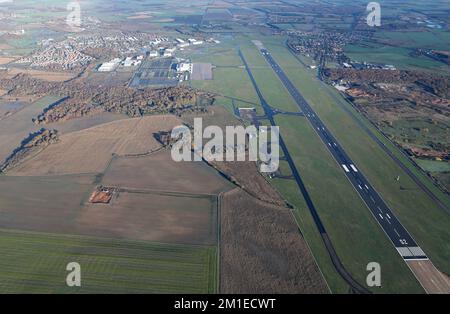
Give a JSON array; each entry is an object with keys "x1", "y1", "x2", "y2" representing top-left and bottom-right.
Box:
[{"x1": 269, "y1": 38, "x2": 450, "y2": 274}]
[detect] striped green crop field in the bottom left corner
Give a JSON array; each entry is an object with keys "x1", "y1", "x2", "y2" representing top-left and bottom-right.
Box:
[{"x1": 0, "y1": 229, "x2": 217, "y2": 293}]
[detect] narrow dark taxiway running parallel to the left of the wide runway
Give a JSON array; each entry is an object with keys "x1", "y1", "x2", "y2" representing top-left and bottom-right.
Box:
[{"x1": 239, "y1": 50, "x2": 370, "y2": 294}]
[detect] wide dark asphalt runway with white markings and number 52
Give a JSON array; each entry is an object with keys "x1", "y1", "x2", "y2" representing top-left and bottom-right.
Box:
[{"x1": 260, "y1": 48, "x2": 428, "y2": 260}]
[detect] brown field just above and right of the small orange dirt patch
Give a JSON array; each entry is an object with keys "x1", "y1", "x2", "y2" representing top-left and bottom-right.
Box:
[{"x1": 102, "y1": 150, "x2": 231, "y2": 194}]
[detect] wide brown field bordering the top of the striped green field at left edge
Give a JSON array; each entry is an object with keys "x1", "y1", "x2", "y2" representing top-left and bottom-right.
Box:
[{"x1": 0, "y1": 175, "x2": 217, "y2": 244}]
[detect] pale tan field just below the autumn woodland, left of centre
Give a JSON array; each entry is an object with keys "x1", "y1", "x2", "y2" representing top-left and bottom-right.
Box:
[{"x1": 9, "y1": 116, "x2": 180, "y2": 176}]
